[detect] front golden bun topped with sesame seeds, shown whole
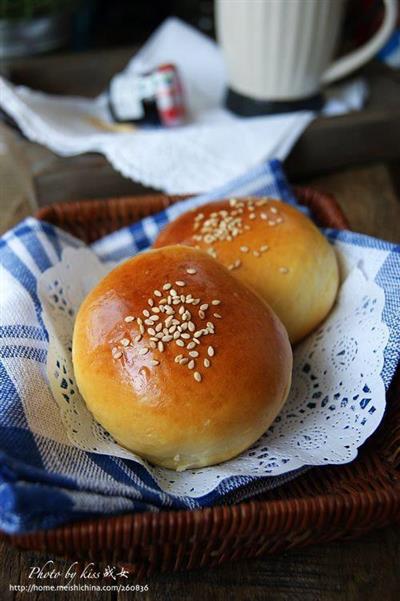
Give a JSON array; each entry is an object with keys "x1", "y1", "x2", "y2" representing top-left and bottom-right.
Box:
[{"x1": 73, "y1": 246, "x2": 292, "y2": 470}]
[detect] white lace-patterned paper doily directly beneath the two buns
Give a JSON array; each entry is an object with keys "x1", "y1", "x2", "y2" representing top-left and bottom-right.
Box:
[{"x1": 38, "y1": 249, "x2": 388, "y2": 497}]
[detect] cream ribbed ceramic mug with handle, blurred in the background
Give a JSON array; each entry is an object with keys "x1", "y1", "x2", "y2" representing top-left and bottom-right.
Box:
[{"x1": 216, "y1": 0, "x2": 397, "y2": 101}]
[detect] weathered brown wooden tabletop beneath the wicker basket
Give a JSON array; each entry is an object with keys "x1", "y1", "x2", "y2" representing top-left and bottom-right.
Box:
[{"x1": 0, "y1": 45, "x2": 400, "y2": 601}]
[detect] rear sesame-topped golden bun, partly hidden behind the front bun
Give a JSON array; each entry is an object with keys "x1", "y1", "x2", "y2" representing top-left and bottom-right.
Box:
[{"x1": 154, "y1": 198, "x2": 339, "y2": 343}]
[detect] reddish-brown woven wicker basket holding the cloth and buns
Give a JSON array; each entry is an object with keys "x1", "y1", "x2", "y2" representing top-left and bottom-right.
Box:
[{"x1": 2, "y1": 188, "x2": 400, "y2": 577}]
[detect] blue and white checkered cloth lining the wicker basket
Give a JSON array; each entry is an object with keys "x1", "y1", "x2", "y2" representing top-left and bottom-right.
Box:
[{"x1": 0, "y1": 161, "x2": 400, "y2": 533}]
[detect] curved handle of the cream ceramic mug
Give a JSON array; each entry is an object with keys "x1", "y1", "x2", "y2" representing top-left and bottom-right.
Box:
[{"x1": 321, "y1": 0, "x2": 397, "y2": 84}]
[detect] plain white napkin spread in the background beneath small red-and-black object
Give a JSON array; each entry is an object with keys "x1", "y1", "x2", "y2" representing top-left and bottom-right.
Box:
[{"x1": 0, "y1": 18, "x2": 367, "y2": 194}]
